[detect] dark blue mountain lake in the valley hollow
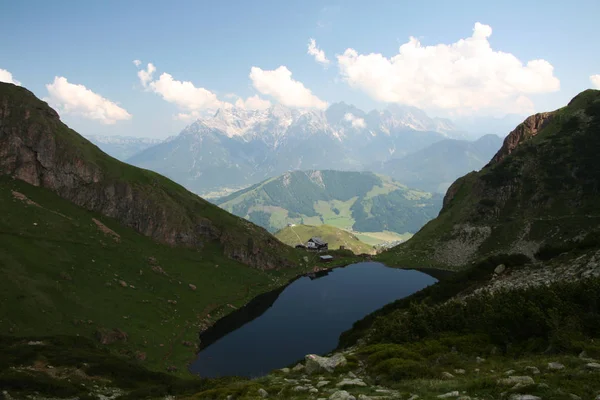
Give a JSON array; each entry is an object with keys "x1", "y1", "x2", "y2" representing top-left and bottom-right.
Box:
[{"x1": 190, "y1": 262, "x2": 437, "y2": 377}]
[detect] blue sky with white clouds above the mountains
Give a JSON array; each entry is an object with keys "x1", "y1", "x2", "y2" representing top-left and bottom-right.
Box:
[{"x1": 0, "y1": 0, "x2": 600, "y2": 138}]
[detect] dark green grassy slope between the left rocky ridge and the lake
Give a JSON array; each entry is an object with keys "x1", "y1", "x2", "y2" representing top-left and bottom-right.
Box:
[{"x1": 0, "y1": 177, "x2": 326, "y2": 372}]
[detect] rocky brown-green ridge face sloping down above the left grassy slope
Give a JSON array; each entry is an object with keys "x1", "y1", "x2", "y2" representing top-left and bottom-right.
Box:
[{"x1": 0, "y1": 83, "x2": 287, "y2": 268}]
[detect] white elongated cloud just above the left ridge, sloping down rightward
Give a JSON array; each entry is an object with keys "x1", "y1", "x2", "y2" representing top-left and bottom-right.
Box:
[{"x1": 44, "y1": 76, "x2": 131, "y2": 124}]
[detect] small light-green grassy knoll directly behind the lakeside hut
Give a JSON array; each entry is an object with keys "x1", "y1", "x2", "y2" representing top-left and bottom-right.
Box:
[{"x1": 275, "y1": 225, "x2": 374, "y2": 254}]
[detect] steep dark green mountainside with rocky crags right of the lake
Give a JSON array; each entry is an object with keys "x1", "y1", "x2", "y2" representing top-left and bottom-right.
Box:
[{"x1": 382, "y1": 90, "x2": 600, "y2": 269}]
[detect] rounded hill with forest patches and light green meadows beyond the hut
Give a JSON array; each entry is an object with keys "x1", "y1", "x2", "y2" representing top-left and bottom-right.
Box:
[{"x1": 215, "y1": 170, "x2": 442, "y2": 233}]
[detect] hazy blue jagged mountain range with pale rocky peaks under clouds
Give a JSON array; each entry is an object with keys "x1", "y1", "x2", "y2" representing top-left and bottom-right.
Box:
[{"x1": 128, "y1": 103, "x2": 461, "y2": 193}]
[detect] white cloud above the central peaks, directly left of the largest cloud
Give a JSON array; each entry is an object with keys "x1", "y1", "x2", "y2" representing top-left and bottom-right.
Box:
[{"x1": 250, "y1": 65, "x2": 327, "y2": 109}]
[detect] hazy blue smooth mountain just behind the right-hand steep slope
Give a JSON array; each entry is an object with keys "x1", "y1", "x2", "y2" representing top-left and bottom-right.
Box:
[{"x1": 370, "y1": 135, "x2": 502, "y2": 193}]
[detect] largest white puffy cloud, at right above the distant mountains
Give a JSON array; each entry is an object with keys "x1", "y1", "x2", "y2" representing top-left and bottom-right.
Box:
[{"x1": 337, "y1": 22, "x2": 560, "y2": 114}]
